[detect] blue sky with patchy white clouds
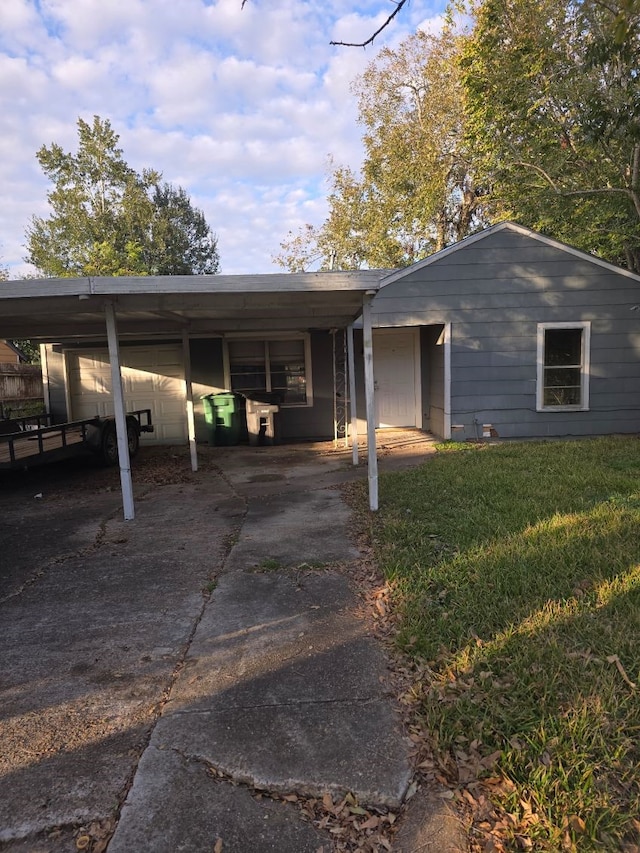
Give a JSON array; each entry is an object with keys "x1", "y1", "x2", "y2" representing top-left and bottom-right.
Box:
[{"x1": 0, "y1": 0, "x2": 444, "y2": 278}]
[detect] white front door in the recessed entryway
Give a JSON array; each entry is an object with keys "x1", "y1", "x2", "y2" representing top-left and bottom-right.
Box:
[{"x1": 373, "y1": 329, "x2": 419, "y2": 427}]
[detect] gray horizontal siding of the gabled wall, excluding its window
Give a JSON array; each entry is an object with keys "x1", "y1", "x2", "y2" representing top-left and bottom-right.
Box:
[{"x1": 372, "y1": 229, "x2": 640, "y2": 438}]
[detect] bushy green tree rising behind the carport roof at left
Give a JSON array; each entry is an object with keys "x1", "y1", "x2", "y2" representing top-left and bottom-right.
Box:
[{"x1": 25, "y1": 116, "x2": 219, "y2": 277}]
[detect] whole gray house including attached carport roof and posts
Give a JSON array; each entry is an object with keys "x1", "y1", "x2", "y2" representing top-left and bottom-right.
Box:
[{"x1": 0, "y1": 222, "x2": 640, "y2": 519}]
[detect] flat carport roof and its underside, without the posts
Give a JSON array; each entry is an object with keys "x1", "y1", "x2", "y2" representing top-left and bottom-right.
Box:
[{"x1": 0, "y1": 270, "x2": 381, "y2": 342}]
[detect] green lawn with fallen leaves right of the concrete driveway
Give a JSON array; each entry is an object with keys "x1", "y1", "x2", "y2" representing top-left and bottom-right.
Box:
[{"x1": 360, "y1": 438, "x2": 640, "y2": 851}]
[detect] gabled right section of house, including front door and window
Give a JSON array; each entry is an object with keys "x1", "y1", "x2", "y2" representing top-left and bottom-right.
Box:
[{"x1": 359, "y1": 222, "x2": 640, "y2": 439}]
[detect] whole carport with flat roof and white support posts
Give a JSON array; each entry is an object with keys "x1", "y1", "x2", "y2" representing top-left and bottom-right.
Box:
[{"x1": 0, "y1": 270, "x2": 380, "y2": 520}]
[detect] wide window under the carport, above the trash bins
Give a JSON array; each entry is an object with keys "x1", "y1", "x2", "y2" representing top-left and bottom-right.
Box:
[{"x1": 227, "y1": 336, "x2": 311, "y2": 406}]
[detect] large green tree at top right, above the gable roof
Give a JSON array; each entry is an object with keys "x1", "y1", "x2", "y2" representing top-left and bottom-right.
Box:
[{"x1": 461, "y1": 0, "x2": 640, "y2": 271}]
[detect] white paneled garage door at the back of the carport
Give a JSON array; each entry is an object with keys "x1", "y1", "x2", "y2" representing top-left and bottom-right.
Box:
[{"x1": 67, "y1": 344, "x2": 187, "y2": 444}]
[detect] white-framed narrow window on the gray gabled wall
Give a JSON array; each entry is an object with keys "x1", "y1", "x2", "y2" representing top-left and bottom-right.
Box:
[{"x1": 537, "y1": 323, "x2": 591, "y2": 411}]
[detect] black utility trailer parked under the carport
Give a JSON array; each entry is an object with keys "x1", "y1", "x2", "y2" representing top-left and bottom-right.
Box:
[{"x1": 0, "y1": 409, "x2": 153, "y2": 470}]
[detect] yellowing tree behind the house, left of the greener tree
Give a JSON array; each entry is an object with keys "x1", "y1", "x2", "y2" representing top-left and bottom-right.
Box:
[{"x1": 276, "y1": 29, "x2": 489, "y2": 269}]
